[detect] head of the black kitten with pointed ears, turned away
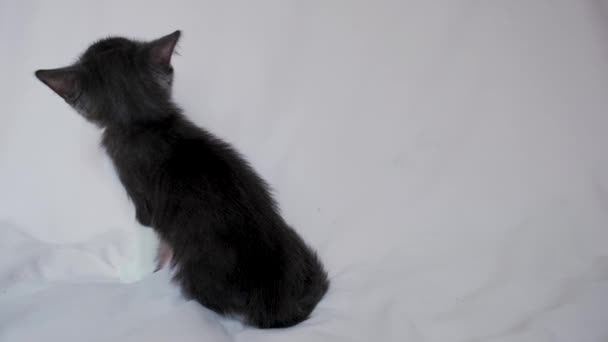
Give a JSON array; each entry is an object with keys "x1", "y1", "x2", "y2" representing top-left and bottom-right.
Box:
[{"x1": 35, "y1": 31, "x2": 180, "y2": 127}]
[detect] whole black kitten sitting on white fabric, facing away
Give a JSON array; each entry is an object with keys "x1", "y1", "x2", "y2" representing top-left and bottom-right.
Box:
[{"x1": 35, "y1": 31, "x2": 329, "y2": 328}]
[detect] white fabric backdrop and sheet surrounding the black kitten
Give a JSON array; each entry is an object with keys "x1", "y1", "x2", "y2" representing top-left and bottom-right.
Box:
[{"x1": 0, "y1": 0, "x2": 608, "y2": 342}]
